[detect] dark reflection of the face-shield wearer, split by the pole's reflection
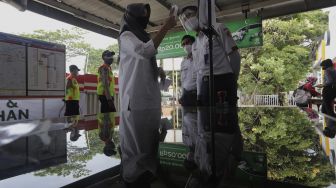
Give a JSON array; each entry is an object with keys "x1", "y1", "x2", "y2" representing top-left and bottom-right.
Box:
[{"x1": 194, "y1": 108, "x2": 243, "y2": 182}]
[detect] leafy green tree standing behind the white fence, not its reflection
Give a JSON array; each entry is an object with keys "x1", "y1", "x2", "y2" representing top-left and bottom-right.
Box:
[{"x1": 239, "y1": 10, "x2": 328, "y2": 94}]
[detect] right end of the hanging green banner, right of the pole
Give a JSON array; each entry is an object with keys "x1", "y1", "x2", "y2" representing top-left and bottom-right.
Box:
[{"x1": 225, "y1": 17, "x2": 263, "y2": 48}]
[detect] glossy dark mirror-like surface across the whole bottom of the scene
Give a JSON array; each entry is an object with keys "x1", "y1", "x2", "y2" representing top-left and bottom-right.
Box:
[{"x1": 0, "y1": 107, "x2": 336, "y2": 187}]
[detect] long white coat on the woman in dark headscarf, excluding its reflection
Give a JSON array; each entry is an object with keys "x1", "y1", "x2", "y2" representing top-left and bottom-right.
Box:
[{"x1": 119, "y1": 31, "x2": 161, "y2": 111}]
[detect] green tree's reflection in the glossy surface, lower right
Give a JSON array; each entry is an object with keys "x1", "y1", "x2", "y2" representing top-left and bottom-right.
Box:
[{"x1": 239, "y1": 108, "x2": 335, "y2": 187}]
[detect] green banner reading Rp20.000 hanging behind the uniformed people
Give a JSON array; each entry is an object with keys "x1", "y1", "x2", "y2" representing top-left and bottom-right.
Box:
[{"x1": 156, "y1": 17, "x2": 263, "y2": 59}]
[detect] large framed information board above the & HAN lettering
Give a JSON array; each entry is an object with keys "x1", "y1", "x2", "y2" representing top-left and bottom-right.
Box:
[{"x1": 0, "y1": 32, "x2": 65, "y2": 98}]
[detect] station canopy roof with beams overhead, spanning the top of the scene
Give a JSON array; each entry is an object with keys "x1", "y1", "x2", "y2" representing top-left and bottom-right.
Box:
[{"x1": 0, "y1": 0, "x2": 336, "y2": 38}]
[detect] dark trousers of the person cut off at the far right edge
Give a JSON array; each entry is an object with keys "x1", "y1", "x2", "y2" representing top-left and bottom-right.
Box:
[{"x1": 322, "y1": 86, "x2": 336, "y2": 117}]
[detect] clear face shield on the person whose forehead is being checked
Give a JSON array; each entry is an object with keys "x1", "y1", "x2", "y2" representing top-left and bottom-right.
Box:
[{"x1": 179, "y1": 9, "x2": 199, "y2": 32}]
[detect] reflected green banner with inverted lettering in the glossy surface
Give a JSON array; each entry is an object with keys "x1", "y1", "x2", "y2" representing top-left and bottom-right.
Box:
[{"x1": 159, "y1": 143, "x2": 189, "y2": 167}]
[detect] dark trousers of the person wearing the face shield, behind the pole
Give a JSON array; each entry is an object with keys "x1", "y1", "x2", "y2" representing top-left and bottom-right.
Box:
[{"x1": 199, "y1": 73, "x2": 238, "y2": 107}]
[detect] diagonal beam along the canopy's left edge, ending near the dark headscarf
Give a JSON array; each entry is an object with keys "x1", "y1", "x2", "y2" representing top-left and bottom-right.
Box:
[{"x1": 27, "y1": 0, "x2": 119, "y2": 38}]
